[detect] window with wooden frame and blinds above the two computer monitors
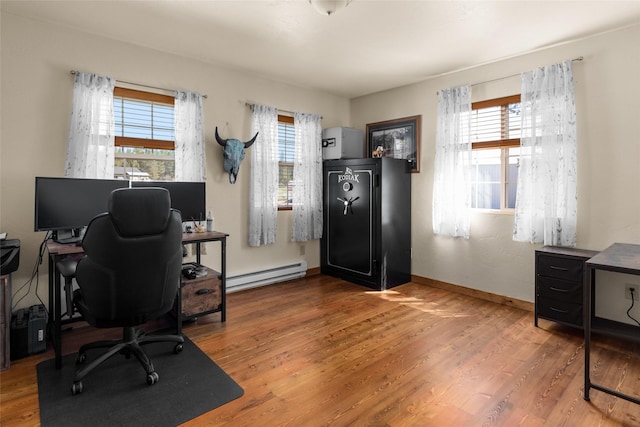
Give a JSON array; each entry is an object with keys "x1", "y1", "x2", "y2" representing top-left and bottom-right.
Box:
[{"x1": 113, "y1": 87, "x2": 175, "y2": 181}]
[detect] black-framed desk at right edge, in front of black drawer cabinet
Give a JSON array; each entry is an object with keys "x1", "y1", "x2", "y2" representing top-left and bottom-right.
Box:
[{"x1": 584, "y1": 243, "x2": 640, "y2": 404}]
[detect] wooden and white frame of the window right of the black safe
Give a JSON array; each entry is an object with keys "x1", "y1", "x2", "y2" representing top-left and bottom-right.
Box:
[{"x1": 471, "y1": 94, "x2": 521, "y2": 214}]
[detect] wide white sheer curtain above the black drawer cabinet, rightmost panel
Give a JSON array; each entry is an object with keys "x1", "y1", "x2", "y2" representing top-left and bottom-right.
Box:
[{"x1": 513, "y1": 61, "x2": 577, "y2": 246}]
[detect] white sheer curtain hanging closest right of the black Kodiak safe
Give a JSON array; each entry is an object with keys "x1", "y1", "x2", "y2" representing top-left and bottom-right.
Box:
[{"x1": 432, "y1": 85, "x2": 471, "y2": 239}]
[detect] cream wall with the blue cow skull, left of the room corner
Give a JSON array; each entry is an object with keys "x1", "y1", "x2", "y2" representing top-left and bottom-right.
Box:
[{"x1": 0, "y1": 13, "x2": 350, "y2": 306}]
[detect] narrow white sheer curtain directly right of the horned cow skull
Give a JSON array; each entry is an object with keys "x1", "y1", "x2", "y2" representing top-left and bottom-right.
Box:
[{"x1": 249, "y1": 105, "x2": 278, "y2": 246}]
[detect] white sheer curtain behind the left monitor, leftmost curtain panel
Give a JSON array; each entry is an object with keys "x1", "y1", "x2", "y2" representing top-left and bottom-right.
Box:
[{"x1": 64, "y1": 72, "x2": 115, "y2": 179}]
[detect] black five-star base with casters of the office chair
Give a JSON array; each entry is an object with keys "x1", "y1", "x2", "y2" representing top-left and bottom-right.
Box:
[{"x1": 71, "y1": 326, "x2": 184, "y2": 395}]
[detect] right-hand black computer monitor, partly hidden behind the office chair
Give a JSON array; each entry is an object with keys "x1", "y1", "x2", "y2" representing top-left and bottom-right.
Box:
[{"x1": 131, "y1": 181, "x2": 207, "y2": 222}]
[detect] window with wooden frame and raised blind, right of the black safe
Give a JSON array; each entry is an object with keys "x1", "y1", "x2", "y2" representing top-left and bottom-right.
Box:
[{"x1": 471, "y1": 95, "x2": 520, "y2": 211}]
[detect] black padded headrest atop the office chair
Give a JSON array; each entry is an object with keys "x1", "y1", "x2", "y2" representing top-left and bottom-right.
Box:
[{"x1": 108, "y1": 187, "x2": 171, "y2": 237}]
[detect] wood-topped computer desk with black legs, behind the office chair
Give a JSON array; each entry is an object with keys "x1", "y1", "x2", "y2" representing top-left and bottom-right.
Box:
[{"x1": 47, "y1": 231, "x2": 229, "y2": 369}]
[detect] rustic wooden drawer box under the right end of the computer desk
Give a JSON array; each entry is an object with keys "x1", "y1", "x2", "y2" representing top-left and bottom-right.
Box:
[{"x1": 181, "y1": 267, "x2": 222, "y2": 318}]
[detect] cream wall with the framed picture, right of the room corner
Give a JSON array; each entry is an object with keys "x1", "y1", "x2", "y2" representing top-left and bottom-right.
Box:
[{"x1": 351, "y1": 26, "x2": 640, "y2": 321}]
